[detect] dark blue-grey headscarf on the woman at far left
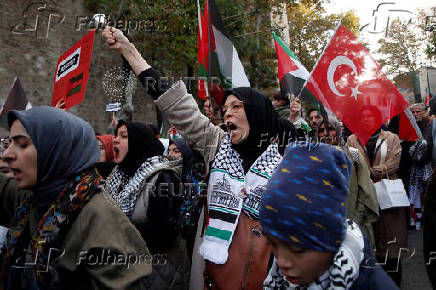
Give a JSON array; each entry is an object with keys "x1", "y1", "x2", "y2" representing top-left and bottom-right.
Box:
[{"x1": 8, "y1": 106, "x2": 100, "y2": 205}]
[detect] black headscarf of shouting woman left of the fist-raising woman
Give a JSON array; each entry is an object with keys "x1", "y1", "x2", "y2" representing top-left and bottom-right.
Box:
[{"x1": 115, "y1": 120, "x2": 164, "y2": 176}]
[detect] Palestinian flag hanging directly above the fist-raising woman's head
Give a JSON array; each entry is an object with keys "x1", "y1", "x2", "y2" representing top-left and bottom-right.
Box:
[{"x1": 197, "y1": 0, "x2": 250, "y2": 106}]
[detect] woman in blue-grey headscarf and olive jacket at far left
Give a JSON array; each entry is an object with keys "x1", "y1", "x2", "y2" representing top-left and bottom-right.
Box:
[{"x1": 0, "y1": 107, "x2": 151, "y2": 289}]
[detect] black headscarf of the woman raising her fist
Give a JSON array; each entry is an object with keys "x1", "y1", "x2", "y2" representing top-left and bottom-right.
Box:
[{"x1": 224, "y1": 87, "x2": 297, "y2": 172}]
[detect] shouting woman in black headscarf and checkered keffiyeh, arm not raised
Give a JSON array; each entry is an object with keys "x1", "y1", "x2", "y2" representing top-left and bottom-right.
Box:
[{"x1": 105, "y1": 120, "x2": 190, "y2": 289}]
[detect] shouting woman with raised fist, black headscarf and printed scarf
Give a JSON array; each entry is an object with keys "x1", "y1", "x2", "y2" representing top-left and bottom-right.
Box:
[{"x1": 103, "y1": 27, "x2": 296, "y2": 289}]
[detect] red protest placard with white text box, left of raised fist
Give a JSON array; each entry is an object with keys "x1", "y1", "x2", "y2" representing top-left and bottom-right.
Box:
[{"x1": 51, "y1": 29, "x2": 95, "y2": 110}]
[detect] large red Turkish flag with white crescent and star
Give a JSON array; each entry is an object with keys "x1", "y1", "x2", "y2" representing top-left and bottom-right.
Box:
[{"x1": 306, "y1": 25, "x2": 409, "y2": 146}]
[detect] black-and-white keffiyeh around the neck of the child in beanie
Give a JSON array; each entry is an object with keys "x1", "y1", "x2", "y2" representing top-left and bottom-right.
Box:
[{"x1": 263, "y1": 220, "x2": 365, "y2": 290}]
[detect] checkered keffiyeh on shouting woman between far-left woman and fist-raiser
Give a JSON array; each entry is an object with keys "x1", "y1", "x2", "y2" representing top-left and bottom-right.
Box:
[{"x1": 105, "y1": 156, "x2": 168, "y2": 216}]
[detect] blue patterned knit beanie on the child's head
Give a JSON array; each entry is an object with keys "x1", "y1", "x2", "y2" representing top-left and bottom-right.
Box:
[{"x1": 260, "y1": 142, "x2": 351, "y2": 252}]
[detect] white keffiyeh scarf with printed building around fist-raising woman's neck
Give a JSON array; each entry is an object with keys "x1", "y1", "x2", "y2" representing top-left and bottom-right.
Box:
[{"x1": 199, "y1": 135, "x2": 282, "y2": 264}]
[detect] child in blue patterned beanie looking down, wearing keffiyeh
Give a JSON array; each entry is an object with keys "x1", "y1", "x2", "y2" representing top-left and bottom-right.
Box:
[{"x1": 260, "y1": 143, "x2": 398, "y2": 289}]
